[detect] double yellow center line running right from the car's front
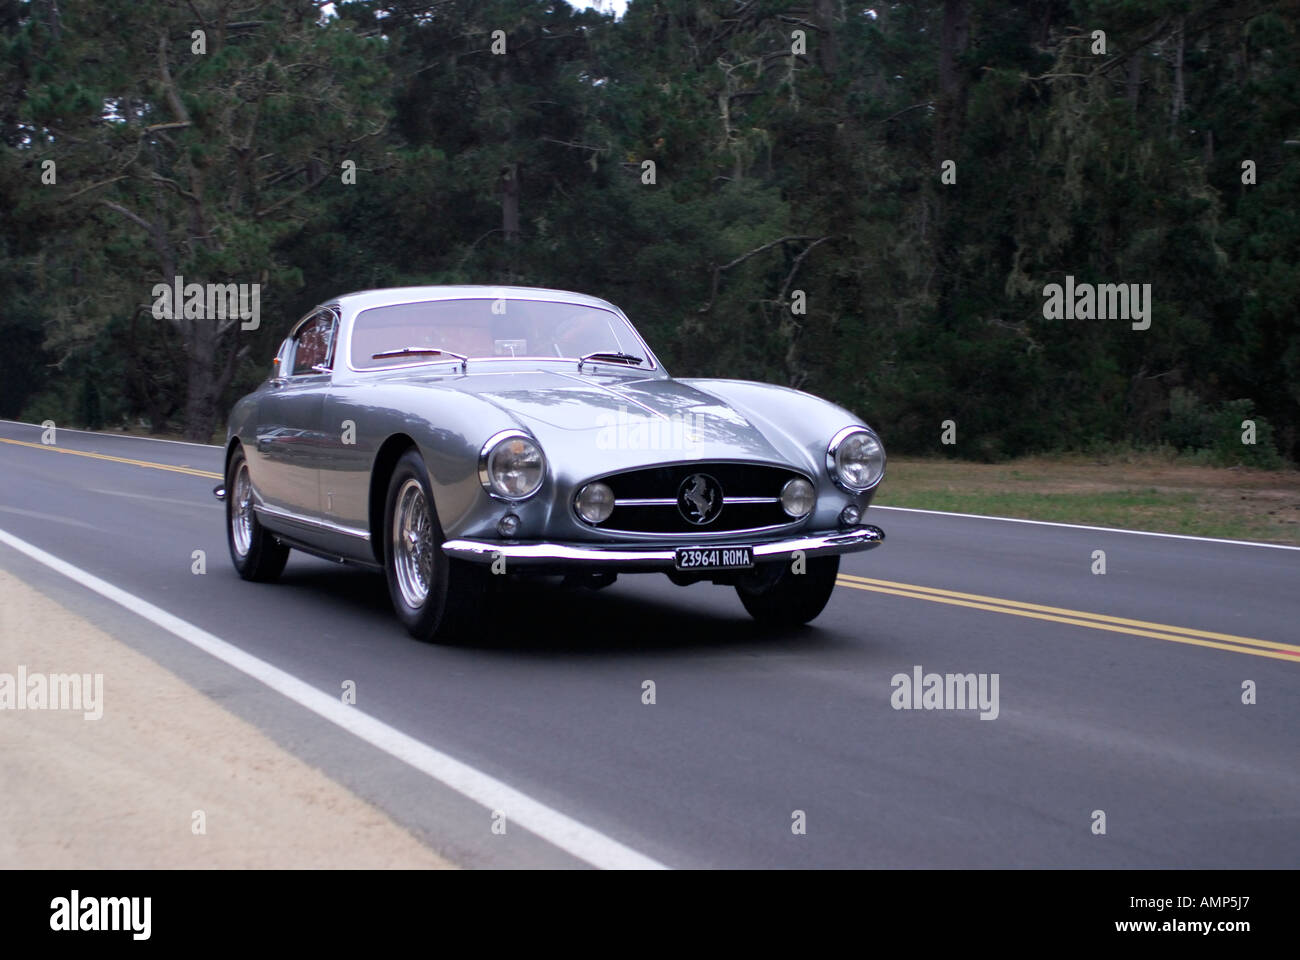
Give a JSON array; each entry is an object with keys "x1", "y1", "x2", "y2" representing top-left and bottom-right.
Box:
[{"x1": 839, "y1": 574, "x2": 1300, "y2": 663}]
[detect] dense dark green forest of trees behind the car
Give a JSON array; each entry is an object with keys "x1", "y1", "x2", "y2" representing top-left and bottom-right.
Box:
[{"x1": 0, "y1": 0, "x2": 1300, "y2": 466}]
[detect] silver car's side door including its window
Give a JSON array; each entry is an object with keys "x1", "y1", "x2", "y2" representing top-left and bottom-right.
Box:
[{"x1": 252, "y1": 308, "x2": 338, "y2": 520}]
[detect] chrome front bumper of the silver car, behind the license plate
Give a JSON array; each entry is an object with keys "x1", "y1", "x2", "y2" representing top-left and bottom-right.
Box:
[{"x1": 442, "y1": 526, "x2": 885, "y2": 570}]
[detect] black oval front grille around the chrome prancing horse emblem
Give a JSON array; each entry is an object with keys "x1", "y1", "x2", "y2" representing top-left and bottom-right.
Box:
[{"x1": 582, "y1": 460, "x2": 807, "y2": 536}]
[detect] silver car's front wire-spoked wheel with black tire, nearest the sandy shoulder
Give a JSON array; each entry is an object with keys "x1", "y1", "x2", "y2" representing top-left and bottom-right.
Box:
[{"x1": 380, "y1": 450, "x2": 489, "y2": 643}]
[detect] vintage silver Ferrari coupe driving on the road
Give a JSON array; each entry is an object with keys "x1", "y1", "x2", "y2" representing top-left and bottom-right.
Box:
[{"x1": 216, "y1": 286, "x2": 885, "y2": 640}]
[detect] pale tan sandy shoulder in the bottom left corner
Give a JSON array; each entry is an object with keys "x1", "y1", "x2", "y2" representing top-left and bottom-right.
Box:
[{"x1": 0, "y1": 571, "x2": 452, "y2": 869}]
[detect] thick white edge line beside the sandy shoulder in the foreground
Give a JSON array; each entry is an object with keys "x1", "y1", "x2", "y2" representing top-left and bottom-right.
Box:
[{"x1": 0, "y1": 529, "x2": 667, "y2": 870}]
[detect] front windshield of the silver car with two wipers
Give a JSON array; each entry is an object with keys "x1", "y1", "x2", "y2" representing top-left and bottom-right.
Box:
[{"x1": 351, "y1": 298, "x2": 649, "y2": 369}]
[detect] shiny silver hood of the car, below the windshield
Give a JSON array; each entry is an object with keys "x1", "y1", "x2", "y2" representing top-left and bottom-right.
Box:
[{"x1": 456, "y1": 371, "x2": 794, "y2": 467}]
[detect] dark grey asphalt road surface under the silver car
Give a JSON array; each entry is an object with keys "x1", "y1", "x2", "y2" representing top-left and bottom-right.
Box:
[{"x1": 0, "y1": 423, "x2": 1300, "y2": 868}]
